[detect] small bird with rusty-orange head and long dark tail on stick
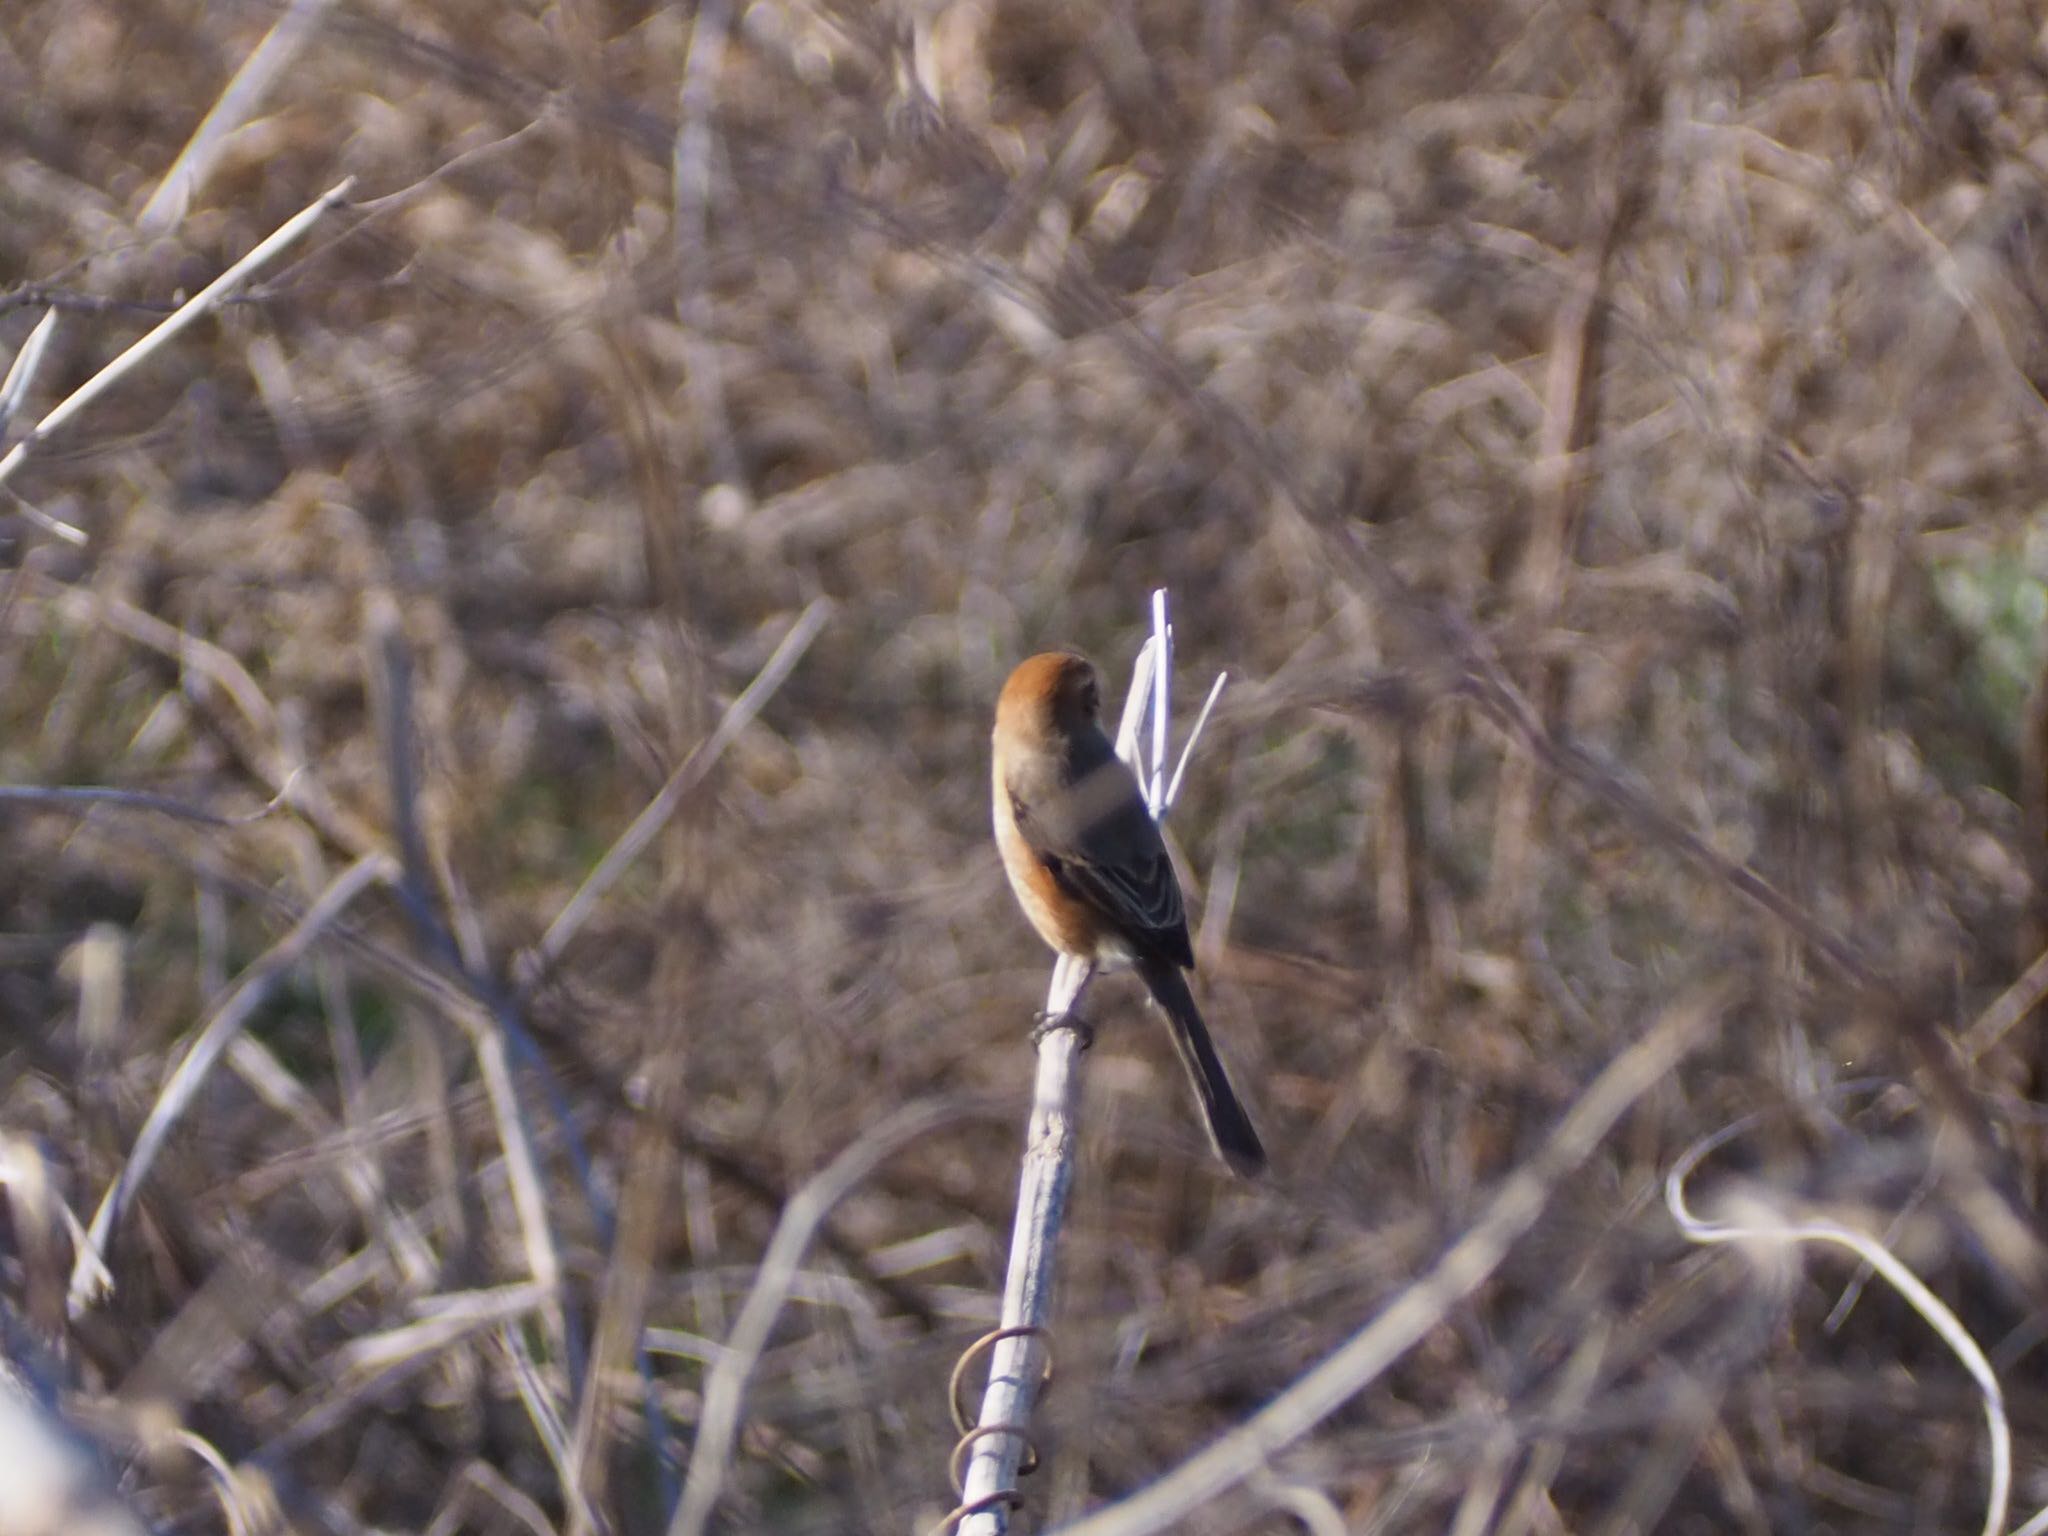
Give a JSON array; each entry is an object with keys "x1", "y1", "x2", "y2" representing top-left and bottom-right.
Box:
[{"x1": 991, "y1": 651, "x2": 1266, "y2": 1178}]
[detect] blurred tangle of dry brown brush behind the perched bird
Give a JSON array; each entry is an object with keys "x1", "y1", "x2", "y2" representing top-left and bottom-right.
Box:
[{"x1": 12, "y1": 0, "x2": 2048, "y2": 1532}]
